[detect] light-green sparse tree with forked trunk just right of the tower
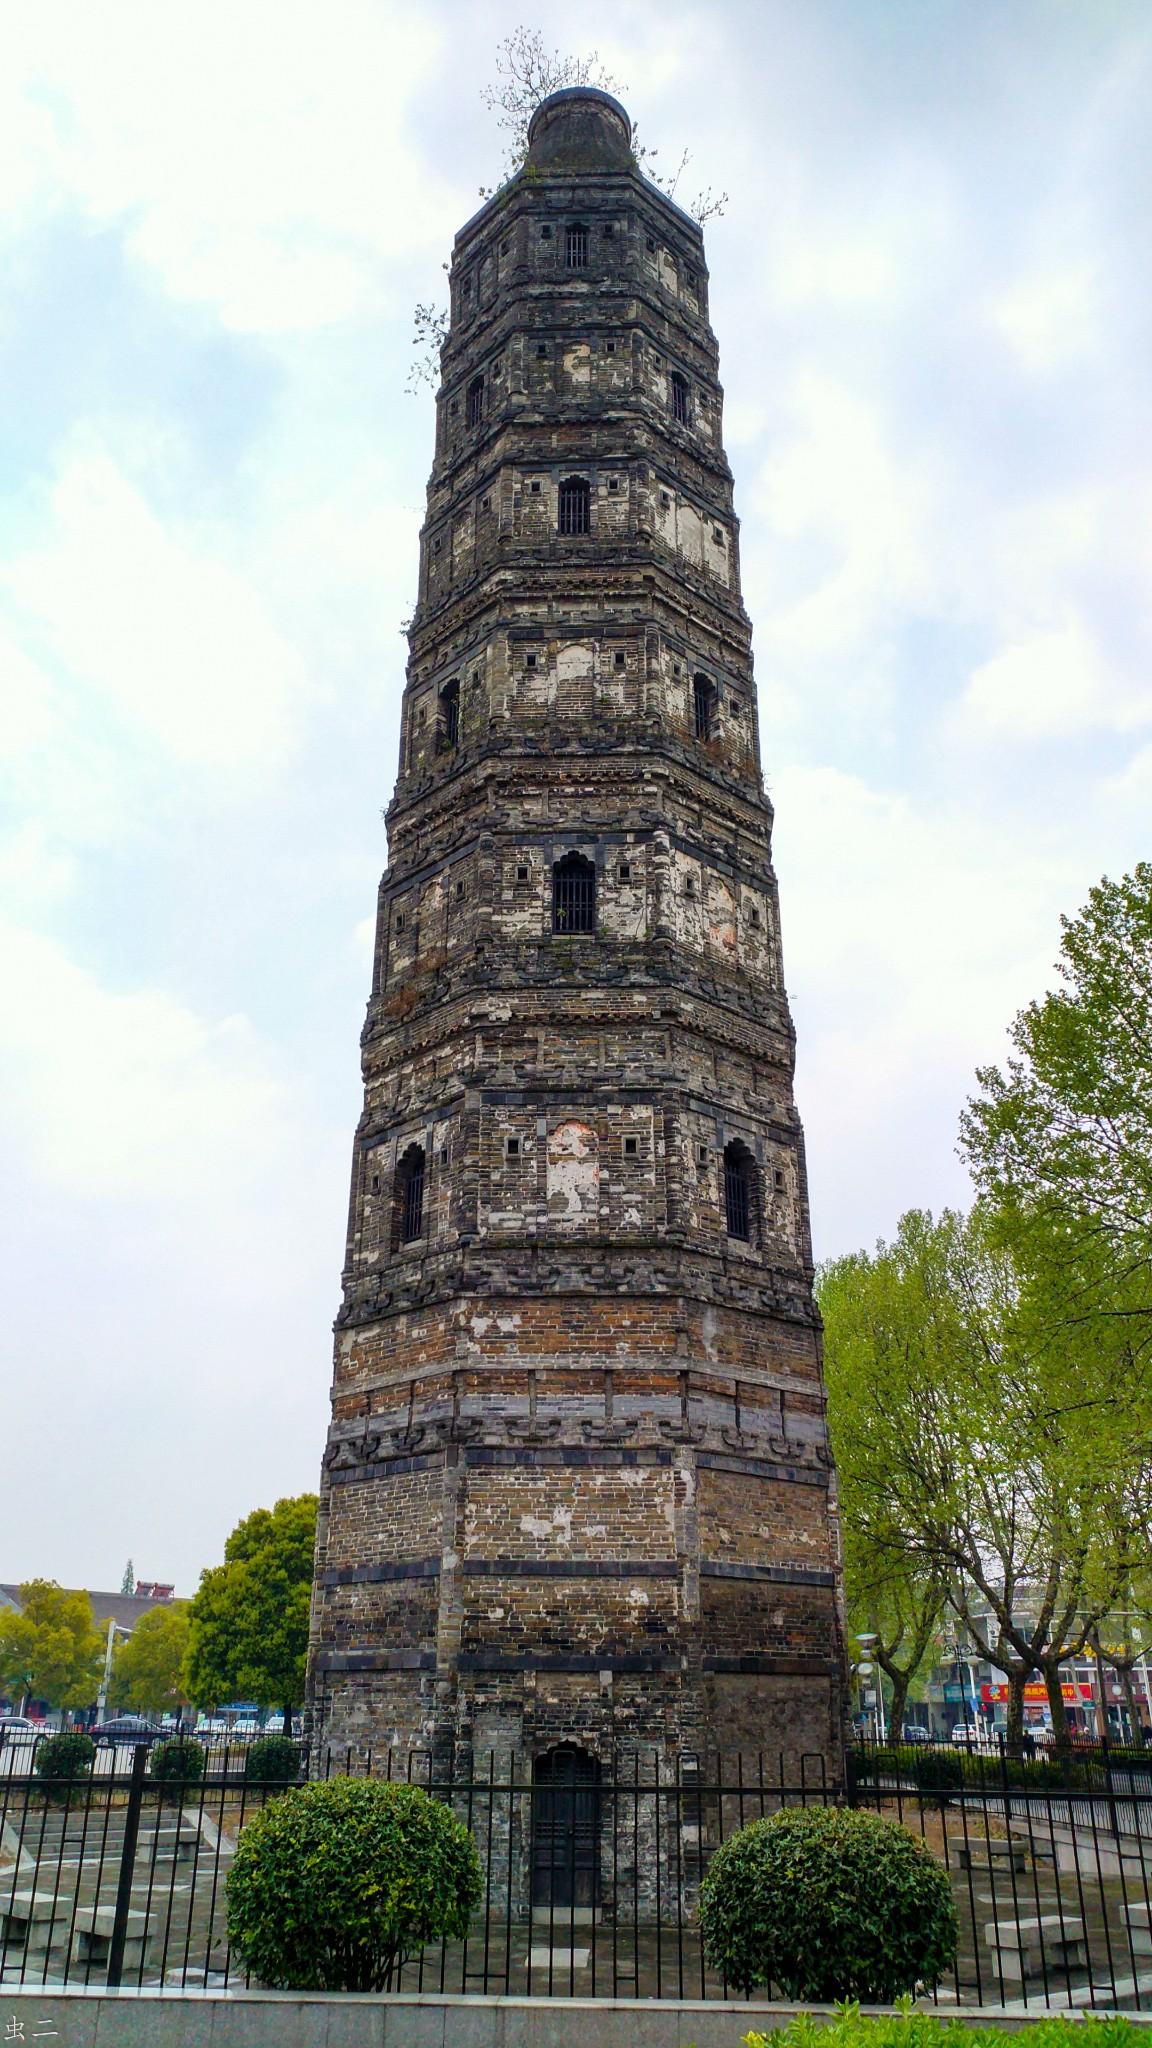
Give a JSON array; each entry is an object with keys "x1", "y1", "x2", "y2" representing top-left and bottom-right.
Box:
[{"x1": 820, "y1": 1208, "x2": 1148, "y2": 1745}]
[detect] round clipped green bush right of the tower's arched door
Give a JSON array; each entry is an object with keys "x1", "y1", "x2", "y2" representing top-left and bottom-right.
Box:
[{"x1": 699, "y1": 1806, "x2": 957, "y2": 2005}]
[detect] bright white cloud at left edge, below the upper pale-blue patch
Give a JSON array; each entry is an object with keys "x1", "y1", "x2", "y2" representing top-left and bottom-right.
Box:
[{"x1": 0, "y1": 444, "x2": 305, "y2": 768}]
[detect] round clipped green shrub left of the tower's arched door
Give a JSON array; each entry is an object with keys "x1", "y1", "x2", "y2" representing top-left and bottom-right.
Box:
[{"x1": 228, "y1": 1778, "x2": 482, "y2": 1991}]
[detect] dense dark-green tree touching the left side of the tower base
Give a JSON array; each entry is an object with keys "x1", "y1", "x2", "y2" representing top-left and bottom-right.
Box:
[{"x1": 184, "y1": 1493, "x2": 318, "y2": 1735}]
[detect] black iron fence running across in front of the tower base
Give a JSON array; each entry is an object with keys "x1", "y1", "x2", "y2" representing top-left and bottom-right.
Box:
[{"x1": 0, "y1": 1745, "x2": 1152, "y2": 2011}]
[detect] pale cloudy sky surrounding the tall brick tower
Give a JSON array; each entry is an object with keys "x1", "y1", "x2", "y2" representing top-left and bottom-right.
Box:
[{"x1": 0, "y1": 0, "x2": 1152, "y2": 1591}]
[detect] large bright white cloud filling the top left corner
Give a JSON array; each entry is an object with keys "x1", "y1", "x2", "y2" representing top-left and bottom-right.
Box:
[{"x1": 0, "y1": 0, "x2": 443, "y2": 334}]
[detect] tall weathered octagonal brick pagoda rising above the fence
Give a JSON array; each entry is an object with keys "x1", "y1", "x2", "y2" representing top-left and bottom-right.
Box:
[{"x1": 310, "y1": 88, "x2": 842, "y2": 1774}]
